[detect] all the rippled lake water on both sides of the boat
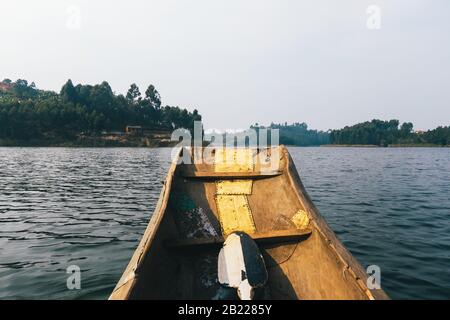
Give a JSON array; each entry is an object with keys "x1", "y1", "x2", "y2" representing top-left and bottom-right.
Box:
[{"x1": 0, "y1": 148, "x2": 450, "y2": 299}]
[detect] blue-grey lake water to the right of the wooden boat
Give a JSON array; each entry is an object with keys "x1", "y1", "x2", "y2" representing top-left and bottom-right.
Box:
[{"x1": 290, "y1": 148, "x2": 450, "y2": 299}]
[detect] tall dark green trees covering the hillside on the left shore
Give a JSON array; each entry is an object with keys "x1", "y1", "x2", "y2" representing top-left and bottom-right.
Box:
[{"x1": 0, "y1": 79, "x2": 201, "y2": 144}]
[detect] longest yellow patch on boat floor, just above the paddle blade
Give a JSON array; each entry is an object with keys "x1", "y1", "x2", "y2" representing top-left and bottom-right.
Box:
[{"x1": 216, "y1": 194, "x2": 256, "y2": 236}]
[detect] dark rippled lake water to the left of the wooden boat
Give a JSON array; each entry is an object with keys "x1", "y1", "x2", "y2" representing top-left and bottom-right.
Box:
[{"x1": 0, "y1": 148, "x2": 170, "y2": 299}]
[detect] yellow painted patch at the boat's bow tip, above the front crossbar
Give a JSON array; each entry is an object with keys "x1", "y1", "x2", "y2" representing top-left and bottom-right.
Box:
[{"x1": 214, "y1": 148, "x2": 253, "y2": 172}]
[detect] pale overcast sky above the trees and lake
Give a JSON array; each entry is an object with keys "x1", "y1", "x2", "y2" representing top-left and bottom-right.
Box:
[{"x1": 0, "y1": 0, "x2": 450, "y2": 129}]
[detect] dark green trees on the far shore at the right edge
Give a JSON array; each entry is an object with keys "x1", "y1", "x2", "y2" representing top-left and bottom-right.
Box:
[{"x1": 330, "y1": 119, "x2": 450, "y2": 147}]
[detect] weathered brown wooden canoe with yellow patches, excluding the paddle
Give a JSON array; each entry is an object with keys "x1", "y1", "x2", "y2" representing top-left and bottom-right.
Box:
[{"x1": 110, "y1": 146, "x2": 388, "y2": 300}]
